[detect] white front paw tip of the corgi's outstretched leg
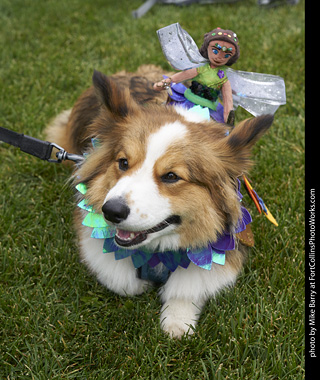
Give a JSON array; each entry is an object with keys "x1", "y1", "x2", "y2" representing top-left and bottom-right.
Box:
[{"x1": 161, "y1": 299, "x2": 201, "y2": 338}]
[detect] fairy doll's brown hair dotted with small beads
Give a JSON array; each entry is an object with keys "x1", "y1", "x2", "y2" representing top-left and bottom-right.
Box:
[{"x1": 199, "y1": 28, "x2": 240, "y2": 66}]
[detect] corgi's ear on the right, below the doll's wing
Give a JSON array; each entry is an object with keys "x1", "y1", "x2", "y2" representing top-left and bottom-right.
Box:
[{"x1": 226, "y1": 115, "x2": 273, "y2": 176}]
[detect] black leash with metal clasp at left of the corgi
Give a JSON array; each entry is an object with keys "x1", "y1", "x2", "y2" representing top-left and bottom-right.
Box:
[{"x1": 0, "y1": 127, "x2": 84, "y2": 164}]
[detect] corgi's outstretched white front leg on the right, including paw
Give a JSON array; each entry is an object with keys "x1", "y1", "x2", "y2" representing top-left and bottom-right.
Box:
[{"x1": 160, "y1": 254, "x2": 242, "y2": 338}]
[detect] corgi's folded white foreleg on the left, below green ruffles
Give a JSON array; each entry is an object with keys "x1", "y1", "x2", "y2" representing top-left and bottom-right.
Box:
[{"x1": 80, "y1": 226, "x2": 151, "y2": 296}]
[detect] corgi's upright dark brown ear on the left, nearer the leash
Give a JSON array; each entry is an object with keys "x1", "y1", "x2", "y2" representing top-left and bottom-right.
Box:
[{"x1": 92, "y1": 70, "x2": 136, "y2": 119}]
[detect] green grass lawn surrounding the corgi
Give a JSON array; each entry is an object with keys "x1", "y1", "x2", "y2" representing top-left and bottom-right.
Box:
[{"x1": 0, "y1": 0, "x2": 304, "y2": 380}]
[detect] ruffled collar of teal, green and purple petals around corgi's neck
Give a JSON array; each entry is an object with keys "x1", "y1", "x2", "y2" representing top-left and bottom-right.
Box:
[{"x1": 76, "y1": 180, "x2": 252, "y2": 272}]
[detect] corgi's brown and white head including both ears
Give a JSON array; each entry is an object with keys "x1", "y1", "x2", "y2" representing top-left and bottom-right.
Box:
[{"x1": 76, "y1": 72, "x2": 273, "y2": 250}]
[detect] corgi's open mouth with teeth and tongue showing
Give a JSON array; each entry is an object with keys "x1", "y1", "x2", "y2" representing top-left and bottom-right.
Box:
[{"x1": 114, "y1": 215, "x2": 181, "y2": 248}]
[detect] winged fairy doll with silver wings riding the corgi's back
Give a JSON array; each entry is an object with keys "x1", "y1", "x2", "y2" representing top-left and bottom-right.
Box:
[{"x1": 153, "y1": 23, "x2": 286, "y2": 123}]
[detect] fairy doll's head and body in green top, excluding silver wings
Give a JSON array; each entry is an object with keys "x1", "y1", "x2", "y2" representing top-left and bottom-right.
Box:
[{"x1": 153, "y1": 28, "x2": 240, "y2": 122}]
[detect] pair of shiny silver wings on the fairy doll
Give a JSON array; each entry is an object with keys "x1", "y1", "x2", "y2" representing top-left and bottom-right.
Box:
[{"x1": 157, "y1": 23, "x2": 286, "y2": 116}]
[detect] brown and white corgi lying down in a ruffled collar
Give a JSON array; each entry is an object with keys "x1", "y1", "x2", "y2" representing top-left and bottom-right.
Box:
[{"x1": 47, "y1": 67, "x2": 273, "y2": 338}]
